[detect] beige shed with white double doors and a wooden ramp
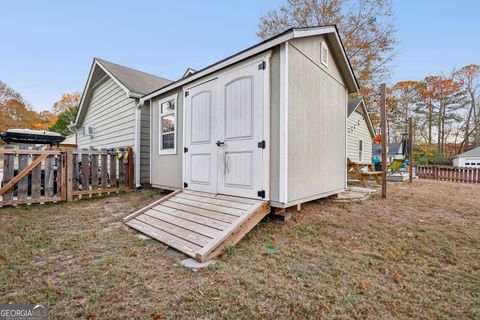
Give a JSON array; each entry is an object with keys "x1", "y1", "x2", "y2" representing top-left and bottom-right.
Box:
[{"x1": 140, "y1": 26, "x2": 358, "y2": 208}]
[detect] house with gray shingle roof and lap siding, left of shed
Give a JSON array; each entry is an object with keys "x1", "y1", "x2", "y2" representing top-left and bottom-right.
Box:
[{"x1": 71, "y1": 58, "x2": 171, "y2": 186}]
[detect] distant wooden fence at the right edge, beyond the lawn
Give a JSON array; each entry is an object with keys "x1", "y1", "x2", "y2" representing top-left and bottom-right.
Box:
[{"x1": 416, "y1": 165, "x2": 480, "y2": 183}]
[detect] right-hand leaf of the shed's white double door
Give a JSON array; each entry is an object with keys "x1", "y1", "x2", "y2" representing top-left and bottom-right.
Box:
[{"x1": 218, "y1": 63, "x2": 265, "y2": 198}]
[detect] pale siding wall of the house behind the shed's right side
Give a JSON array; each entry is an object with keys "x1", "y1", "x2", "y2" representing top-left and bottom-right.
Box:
[{"x1": 347, "y1": 110, "x2": 372, "y2": 164}]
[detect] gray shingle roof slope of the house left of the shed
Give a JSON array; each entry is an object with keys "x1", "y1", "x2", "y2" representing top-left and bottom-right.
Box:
[{"x1": 95, "y1": 58, "x2": 172, "y2": 94}]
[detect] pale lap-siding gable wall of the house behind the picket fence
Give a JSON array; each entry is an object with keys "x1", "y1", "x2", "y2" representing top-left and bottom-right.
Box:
[{"x1": 77, "y1": 77, "x2": 135, "y2": 149}]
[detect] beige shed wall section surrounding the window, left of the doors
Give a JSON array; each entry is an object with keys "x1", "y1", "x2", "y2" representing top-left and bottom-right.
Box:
[{"x1": 150, "y1": 88, "x2": 183, "y2": 189}]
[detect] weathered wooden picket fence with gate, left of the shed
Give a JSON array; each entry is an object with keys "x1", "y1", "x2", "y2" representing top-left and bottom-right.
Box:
[{"x1": 0, "y1": 147, "x2": 134, "y2": 206}]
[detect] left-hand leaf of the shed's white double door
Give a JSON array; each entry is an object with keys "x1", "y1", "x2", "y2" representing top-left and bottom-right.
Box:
[{"x1": 184, "y1": 80, "x2": 218, "y2": 193}]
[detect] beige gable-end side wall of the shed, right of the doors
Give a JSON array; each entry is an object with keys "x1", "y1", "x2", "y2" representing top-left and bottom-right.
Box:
[{"x1": 287, "y1": 37, "x2": 347, "y2": 203}]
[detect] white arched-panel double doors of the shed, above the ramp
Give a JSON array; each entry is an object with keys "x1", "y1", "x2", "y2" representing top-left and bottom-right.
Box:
[{"x1": 184, "y1": 63, "x2": 265, "y2": 199}]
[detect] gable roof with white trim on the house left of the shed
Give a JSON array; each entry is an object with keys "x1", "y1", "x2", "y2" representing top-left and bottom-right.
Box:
[{"x1": 74, "y1": 58, "x2": 172, "y2": 125}]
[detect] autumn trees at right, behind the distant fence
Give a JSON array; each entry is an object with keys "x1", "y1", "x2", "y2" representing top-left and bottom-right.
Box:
[{"x1": 373, "y1": 64, "x2": 480, "y2": 163}]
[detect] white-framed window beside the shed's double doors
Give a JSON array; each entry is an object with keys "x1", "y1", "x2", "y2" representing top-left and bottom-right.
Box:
[{"x1": 158, "y1": 95, "x2": 177, "y2": 154}]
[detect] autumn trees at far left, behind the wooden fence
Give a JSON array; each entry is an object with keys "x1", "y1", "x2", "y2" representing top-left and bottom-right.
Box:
[{"x1": 0, "y1": 81, "x2": 80, "y2": 136}]
